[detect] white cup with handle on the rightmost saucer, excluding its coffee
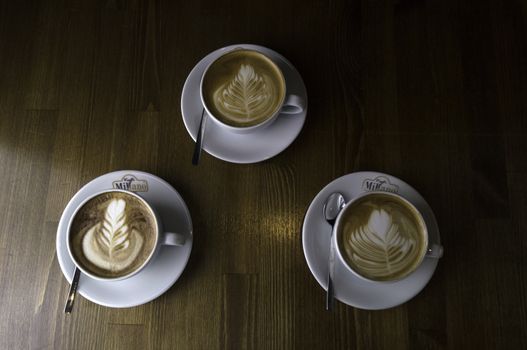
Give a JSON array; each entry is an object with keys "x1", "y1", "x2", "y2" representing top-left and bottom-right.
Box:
[{"x1": 331, "y1": 191, "x2": 443, "y2": 283}]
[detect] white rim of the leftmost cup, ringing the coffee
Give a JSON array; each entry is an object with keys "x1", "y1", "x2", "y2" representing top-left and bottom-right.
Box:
[{"x1": 66, "y1": 188, "x2": 161, "y2": 282}]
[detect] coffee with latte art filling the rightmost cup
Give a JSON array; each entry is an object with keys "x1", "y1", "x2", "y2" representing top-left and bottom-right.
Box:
[{"x1": 337, "y1": 193, "x2": 428, "y2": 281}]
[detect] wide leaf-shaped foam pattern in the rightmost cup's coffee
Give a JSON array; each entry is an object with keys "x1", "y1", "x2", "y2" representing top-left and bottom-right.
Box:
[{"x1": 344, "y1": 208, "x2": 419, "y2": 279}]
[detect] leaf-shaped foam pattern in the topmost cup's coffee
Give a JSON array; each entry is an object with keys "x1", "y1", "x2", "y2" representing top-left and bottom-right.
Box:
[{"x1": 213, "y1": 64, "x2": 276, "y2": 122}]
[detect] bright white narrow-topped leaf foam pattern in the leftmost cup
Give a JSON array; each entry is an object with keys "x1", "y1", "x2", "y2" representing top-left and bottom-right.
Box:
[{"x1": 82, "y1": 199, "x2": 143, "y2": 272}]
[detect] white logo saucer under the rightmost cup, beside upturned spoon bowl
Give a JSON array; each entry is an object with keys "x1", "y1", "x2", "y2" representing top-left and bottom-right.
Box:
[{"x1": 302, "y1": 171, "x2": 440, "y2": 310}]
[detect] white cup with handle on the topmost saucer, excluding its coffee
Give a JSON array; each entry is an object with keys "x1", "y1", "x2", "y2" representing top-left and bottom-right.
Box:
[{"x1": 200, "y1": 46, "x2": 305, "y2": 134}]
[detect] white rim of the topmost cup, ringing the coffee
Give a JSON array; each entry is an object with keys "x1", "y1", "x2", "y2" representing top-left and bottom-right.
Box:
[{"x1": 199, "y1": 44, "x2": 287, "y2": 133}]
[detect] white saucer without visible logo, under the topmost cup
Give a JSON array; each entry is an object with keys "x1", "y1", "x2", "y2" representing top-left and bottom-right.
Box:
[{"x1": 181, "y1": 44, "x2": 307, "y2": 163}]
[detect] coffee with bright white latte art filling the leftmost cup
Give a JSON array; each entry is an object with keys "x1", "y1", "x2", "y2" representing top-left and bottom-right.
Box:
[{"x1": 69, "y1": 191, "x2": 157, "y2": 278}]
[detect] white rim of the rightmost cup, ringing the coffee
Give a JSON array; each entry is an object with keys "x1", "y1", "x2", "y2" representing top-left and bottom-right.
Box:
[{"x1": 331, "y1": 191, "x2": 430, "y2": 284}]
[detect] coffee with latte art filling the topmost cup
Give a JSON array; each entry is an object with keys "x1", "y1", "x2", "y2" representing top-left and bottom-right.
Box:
[{"x1": 201, "y1": 49, "x2": 286, "y2": 127}]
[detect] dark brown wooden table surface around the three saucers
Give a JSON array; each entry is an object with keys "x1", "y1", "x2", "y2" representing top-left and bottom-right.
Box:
[{"x1": 0, "y1": 0, "x2": 527, "y2": 349}]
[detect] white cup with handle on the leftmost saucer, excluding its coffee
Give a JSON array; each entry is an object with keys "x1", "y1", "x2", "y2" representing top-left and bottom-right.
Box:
[{"x1": 66, "y1": 189, "x2": 186, "y2": 281}]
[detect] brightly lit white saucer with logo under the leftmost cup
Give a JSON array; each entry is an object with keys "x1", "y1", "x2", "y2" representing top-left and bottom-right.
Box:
[{"x1": 57, "y1": 170, "x2": 193, "y2": 307}]
